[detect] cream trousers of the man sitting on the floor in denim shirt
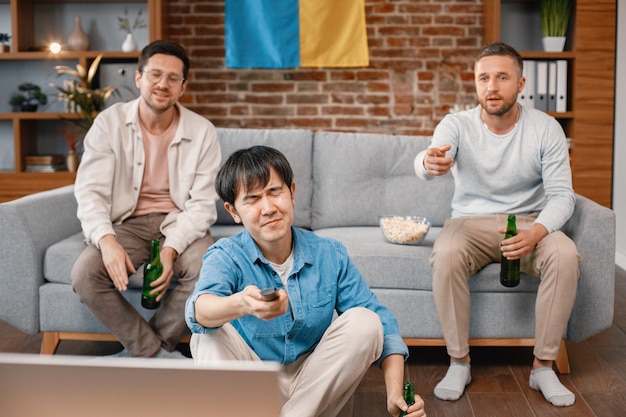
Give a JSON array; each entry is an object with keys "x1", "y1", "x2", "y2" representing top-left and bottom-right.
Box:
[{"x1": 190, "y1": 307, "x2": 383, "y2": 417}]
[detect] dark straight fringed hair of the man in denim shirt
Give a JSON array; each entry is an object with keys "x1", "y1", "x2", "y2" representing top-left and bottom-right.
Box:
[{"x1": 215, "y1": 145, "x2": 293, "y2": 205}]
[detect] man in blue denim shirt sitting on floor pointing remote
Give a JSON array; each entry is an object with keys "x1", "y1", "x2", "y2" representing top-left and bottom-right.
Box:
[{"x1": 185, "y1": 146, "x2": 425, "y2": 417}]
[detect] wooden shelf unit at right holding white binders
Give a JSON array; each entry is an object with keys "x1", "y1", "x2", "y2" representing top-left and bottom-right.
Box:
[{"x1": 483, "y1": 0, "x2": 617, "y2": 208}]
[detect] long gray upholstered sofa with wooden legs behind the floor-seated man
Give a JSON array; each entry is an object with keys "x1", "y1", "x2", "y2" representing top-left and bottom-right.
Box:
[{"x1": 0, "y1": 129, "x2": 615, "y2": 372}]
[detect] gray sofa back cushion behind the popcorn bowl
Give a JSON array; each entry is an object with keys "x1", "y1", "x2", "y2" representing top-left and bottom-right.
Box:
[{"x1": 312, "y1": 132, "x2": 454, "y2": 230}]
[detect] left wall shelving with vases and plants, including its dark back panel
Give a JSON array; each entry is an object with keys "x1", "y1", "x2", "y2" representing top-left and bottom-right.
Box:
[{"x1": 0, "y1": 0, "x2": 163, "y2": 202}]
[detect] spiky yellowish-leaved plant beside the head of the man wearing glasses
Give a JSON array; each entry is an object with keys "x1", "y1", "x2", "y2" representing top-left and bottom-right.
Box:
[{"x1": 50, "y1": 54, "x2": 119, "y2": 133}]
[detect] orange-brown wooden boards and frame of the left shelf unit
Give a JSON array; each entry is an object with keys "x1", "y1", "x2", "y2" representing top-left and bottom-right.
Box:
[{"x1": 0, "y1": 0, "x2": 163, "y2": 202}]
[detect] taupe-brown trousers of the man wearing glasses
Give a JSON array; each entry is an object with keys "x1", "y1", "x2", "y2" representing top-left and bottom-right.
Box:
[{"x1": 71, "y1": 213, "x2": 213, "y2": 357}]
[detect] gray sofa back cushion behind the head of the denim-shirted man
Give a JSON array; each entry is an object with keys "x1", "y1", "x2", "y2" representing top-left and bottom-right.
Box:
[{"x1": 216, "y1": 128, "x2": 313, "y2": 229}]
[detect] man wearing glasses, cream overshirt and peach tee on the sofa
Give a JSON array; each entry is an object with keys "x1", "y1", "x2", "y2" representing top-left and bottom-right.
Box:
[{"x1": 72, "y1": 40, "x2": 221, "y2": 358}]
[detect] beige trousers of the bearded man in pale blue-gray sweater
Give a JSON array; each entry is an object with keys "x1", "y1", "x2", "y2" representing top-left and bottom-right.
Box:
[{"x1": 430, "y1": 215, "x2": 580, "y2": 360}]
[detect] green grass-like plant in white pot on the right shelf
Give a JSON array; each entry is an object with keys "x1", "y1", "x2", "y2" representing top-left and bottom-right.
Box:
[{"x1": 540, "y1": 0, "x2": 570, "y2": 52}]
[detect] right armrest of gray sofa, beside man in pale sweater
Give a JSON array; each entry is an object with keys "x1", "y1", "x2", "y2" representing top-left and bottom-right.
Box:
[{"x1": 563, "y1": 194, "x2": 615, "y2": 342}]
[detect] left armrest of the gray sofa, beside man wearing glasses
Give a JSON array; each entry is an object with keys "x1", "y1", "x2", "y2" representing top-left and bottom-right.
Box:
[{"x1": 0, "y1": 185, "x2": 81, "y2": 334}]
